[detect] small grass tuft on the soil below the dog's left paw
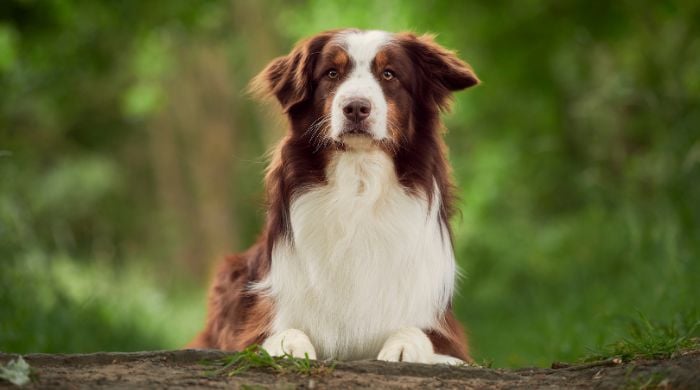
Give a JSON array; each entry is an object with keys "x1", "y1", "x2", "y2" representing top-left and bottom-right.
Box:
[{"x1": 209, "y1": 345, "x2": 335, "y2": 376}]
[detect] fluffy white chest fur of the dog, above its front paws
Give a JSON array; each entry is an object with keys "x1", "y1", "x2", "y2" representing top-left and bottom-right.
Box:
[{"x1": 260, "y1": 150, "x2": 455, "y2": 360}]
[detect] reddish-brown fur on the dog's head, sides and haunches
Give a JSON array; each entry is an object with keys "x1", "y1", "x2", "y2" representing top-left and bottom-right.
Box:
[{"x1": 189, "y1": 31, "x2": 479, "y2": 361}]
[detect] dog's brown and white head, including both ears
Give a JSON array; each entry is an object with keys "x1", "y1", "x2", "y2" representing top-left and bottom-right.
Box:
[{"x1": 256, "y1": 30, "x2": 479, "y2": 152}]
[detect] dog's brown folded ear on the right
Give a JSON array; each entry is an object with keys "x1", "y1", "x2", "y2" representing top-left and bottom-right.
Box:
[{"x1": 398, "y1": 33, "x2": 480, "y2": 108}]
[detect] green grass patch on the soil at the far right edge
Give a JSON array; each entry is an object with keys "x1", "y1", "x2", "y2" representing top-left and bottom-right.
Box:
[{"x1": 584, "y1": 313, "x2": 700, "y2": 361}]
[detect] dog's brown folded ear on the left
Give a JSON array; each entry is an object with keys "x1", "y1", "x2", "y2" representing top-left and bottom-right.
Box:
[{"x1": 250, "y1": 33, "x2": 331, "y2": 112}]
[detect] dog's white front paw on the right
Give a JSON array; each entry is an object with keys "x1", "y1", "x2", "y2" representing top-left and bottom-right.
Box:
[{"x1": 377, "y1": 328, "x2": 435, "y2": 363}]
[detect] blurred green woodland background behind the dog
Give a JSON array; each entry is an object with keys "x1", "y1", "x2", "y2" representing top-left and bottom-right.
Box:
[{"x1": 0, "y1": 0, "x2": 700, "y2": 366}]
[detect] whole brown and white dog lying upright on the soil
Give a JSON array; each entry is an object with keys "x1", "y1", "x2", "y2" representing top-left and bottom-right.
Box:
[{"x1": 189, "y1": 30, "x2": 479, "y2": 363}]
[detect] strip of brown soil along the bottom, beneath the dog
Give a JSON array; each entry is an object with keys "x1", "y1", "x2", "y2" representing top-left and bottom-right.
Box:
[{"x1": 0, "y1": 350, "x2": 700, "y2": 389}]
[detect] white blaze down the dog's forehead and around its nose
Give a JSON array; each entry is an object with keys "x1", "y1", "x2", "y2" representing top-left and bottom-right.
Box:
[{"x1": 330, "y1": 31, "x2": 391, "y2": 140}]
